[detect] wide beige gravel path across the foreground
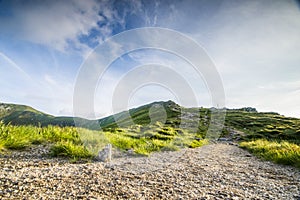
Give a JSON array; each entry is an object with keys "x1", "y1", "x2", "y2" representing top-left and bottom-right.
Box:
[{"x1": 0, "y1": 143, "x2": 300, "y2": 199}]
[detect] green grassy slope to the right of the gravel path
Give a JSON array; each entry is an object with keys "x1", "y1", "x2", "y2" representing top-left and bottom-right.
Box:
[{"x1": 225, "y1": 110, "x2": 300, "y2": 168}]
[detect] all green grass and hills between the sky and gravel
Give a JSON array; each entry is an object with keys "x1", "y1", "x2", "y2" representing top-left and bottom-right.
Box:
[{"x1": 0, "y1": 101, "x2": 300, "y2": 166}]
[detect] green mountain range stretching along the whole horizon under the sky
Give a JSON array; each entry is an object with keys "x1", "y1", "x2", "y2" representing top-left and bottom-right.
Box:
[{"x1": 0, "y1": 101, "x2": 300, "y2": 143}]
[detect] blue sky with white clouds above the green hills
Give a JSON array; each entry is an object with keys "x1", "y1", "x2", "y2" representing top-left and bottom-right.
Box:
[{"x1": 0, "y1": 0, "x2": 300, "y2": 118}]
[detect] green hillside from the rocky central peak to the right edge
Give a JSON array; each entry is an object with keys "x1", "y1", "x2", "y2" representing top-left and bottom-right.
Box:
[{"x1": 99, "y1": 101, "x2": 300, "y2": 143}]
